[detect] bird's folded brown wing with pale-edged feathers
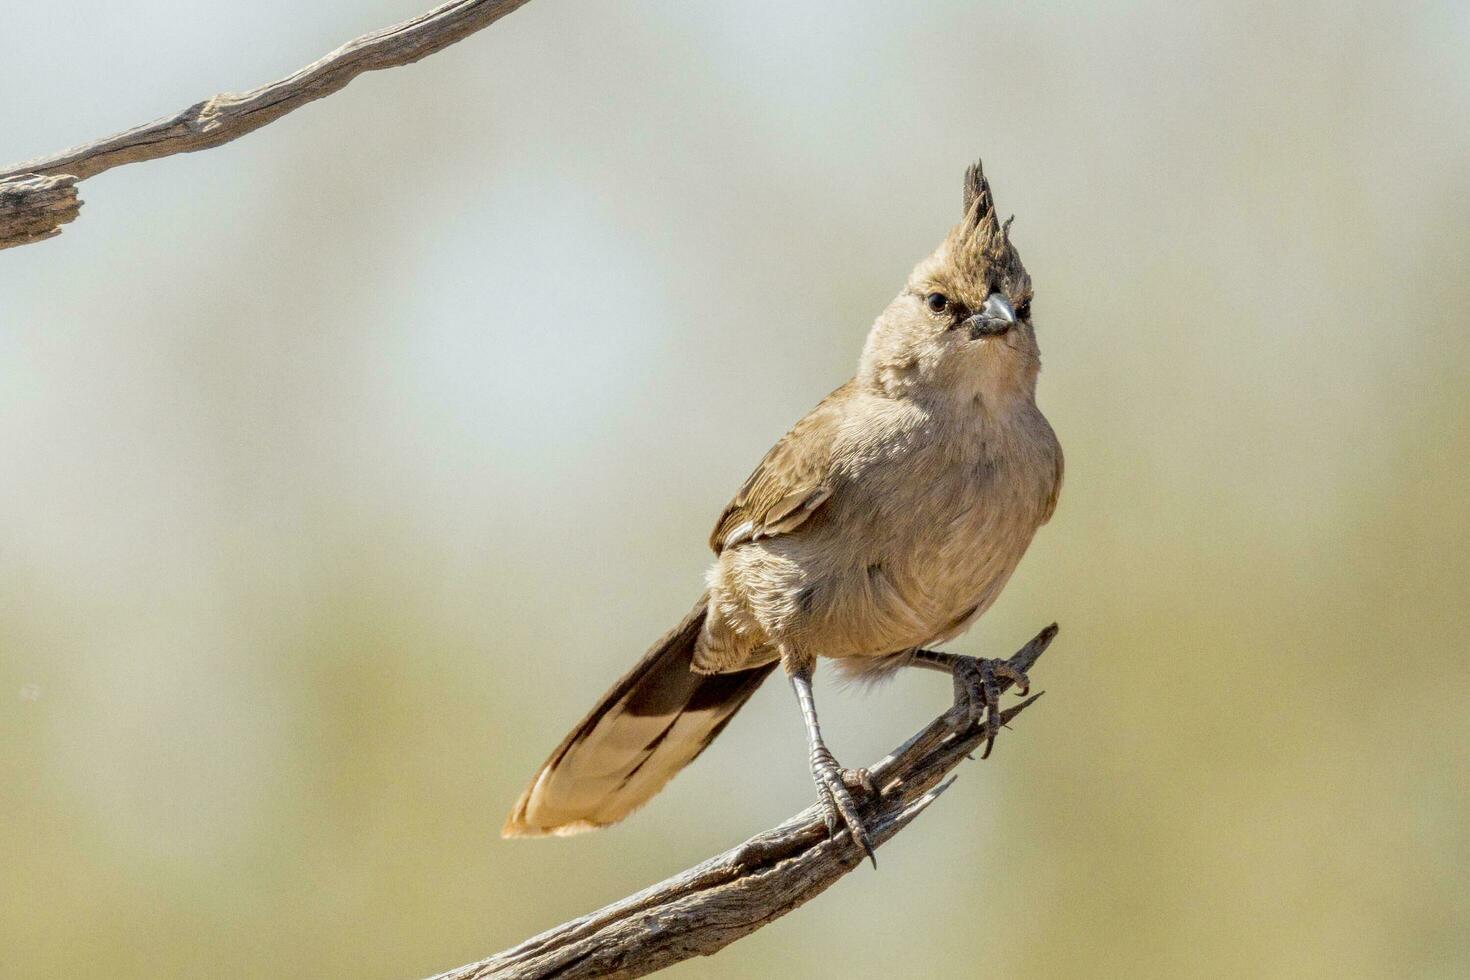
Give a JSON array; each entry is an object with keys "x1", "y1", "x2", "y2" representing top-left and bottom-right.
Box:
[{"x1": 710, "y1": 382, "x2": 853, "y2": 554}]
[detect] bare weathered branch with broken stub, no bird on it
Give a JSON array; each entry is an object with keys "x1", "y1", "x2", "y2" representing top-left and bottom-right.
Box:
[{"x1": 0, "y1": 0, "x2": 528, "y2": 248}]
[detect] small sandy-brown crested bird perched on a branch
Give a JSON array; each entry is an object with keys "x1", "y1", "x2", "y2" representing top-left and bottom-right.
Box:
[{"x1": 501, "y1": 160, "x2": 1063, "y2": 865}]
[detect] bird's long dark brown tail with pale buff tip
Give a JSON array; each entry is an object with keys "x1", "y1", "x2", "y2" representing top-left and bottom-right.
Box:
[{"x1": 500, "y1": 598, "x2": 775, "y2": 837}]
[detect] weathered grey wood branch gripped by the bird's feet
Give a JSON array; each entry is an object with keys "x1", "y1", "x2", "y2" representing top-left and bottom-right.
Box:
[{"x1": 434, "y1": 623, "x2": 1057, "y2": 980}]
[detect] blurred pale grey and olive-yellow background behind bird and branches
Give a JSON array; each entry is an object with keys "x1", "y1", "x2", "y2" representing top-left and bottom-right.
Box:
[{"x1": 0, "y1": 0, "x2": 1470, "y2": 977}]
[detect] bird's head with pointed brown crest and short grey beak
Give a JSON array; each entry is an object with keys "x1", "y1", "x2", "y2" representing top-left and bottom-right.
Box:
[{"x1": 858, "y1": 162, "x2": 1041, "y2": 403}]
